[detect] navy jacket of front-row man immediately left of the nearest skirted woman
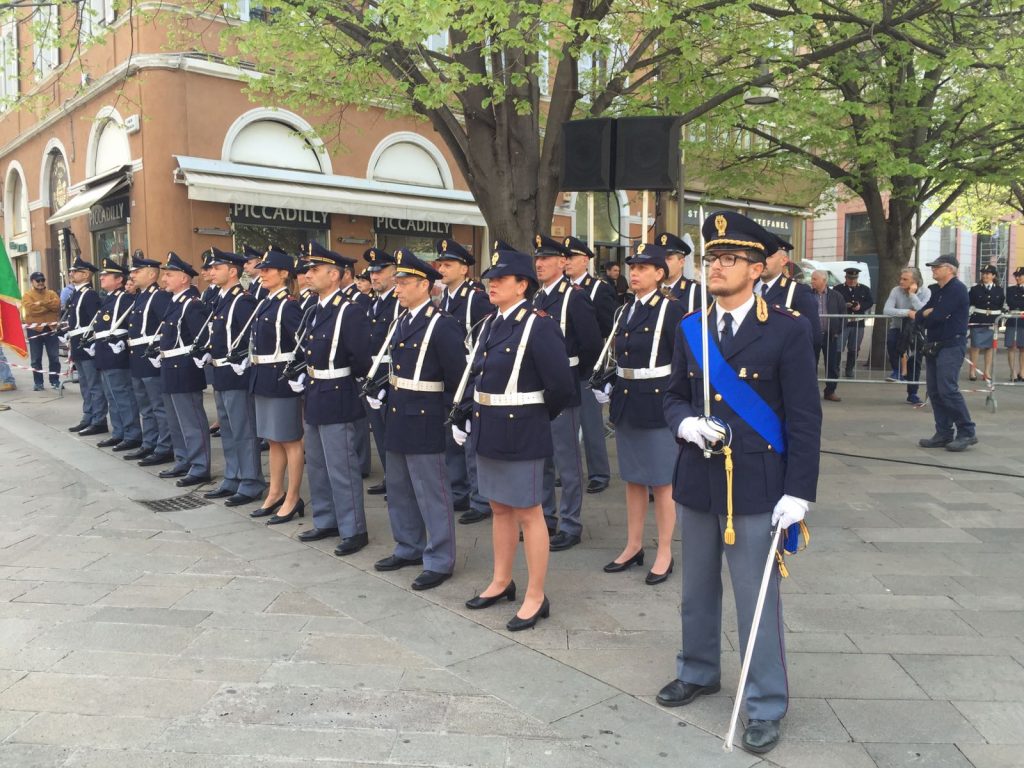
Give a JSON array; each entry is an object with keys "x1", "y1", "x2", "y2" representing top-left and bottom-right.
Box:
[{"x1": 384, "y1": 304, "x2": 466, "y2": 454}]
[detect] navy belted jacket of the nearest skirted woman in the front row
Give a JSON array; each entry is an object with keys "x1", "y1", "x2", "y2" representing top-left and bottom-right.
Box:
[{"x1": 466, "y1": 299, "x2": 577, "y2": 461}]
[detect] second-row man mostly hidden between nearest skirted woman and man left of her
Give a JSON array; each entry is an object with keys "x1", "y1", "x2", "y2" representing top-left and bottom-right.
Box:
[{"x1": 433, "y1": 238, "x2": 495, "y2": 524}]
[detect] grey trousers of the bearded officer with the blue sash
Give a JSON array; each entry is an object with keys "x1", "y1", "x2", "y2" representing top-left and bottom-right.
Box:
[{"x1": 676, "y1": 505, "x2": 790, "y2": 720}]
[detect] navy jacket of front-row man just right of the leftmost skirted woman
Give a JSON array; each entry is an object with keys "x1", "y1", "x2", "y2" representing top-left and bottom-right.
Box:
[{"x1": 302, "y1": 294, "x2": 371, "y2": 425}]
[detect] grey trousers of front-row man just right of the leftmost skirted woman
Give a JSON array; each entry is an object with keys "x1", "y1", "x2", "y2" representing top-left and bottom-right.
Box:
[{"x1": 302, "y1": 422, "x2": 367, "y2": 539}]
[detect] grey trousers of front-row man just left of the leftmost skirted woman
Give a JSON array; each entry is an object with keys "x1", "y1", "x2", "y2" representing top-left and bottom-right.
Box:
[{"x1": 213, "y1": 389, "x2": 266, "y2": 497}]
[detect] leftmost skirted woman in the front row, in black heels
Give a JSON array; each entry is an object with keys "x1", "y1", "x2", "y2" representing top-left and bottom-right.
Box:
[{"x1": 249, "y1": 250, "x2": 305, "y2": 525}]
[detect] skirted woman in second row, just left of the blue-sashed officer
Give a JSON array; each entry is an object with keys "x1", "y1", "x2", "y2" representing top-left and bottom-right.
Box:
[{"x1": 594, "y1": 243, "x2": 685, "y2": 585}]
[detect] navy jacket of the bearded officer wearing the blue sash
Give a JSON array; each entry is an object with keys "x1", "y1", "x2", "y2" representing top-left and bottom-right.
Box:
[{"x1": 665, "y1": 304, "x2": 821, "y2": 515}]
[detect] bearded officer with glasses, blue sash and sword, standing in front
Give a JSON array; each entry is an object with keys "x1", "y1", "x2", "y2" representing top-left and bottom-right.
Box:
[{"x1": 657, "y1": 212, "x2": 821, "y2": 754}]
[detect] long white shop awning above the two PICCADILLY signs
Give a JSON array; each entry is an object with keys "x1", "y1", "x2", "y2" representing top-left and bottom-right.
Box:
[{"x1": 176, "y1": 157, "x2": 484, "y2": 226}]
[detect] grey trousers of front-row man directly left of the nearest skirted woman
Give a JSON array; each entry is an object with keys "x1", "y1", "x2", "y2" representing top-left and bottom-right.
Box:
[{"x1": 386, "y1": 451, "x2": 455, "y2": 573}]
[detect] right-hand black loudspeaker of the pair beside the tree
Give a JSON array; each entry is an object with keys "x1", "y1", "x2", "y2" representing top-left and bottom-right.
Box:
[{"x1": 615, "y1": 118, "x2": 681, "y2": 191}]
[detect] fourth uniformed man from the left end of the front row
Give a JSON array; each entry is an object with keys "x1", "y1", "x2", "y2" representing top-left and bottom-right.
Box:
[{"x1": 153, "y1": 256, "x2": 210, "y2": 487}]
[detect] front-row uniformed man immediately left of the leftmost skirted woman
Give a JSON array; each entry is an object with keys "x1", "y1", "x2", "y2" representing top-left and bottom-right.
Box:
[{"x1": 204, "y1": 248, "x2": 266, "y2": 507}]
